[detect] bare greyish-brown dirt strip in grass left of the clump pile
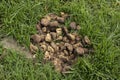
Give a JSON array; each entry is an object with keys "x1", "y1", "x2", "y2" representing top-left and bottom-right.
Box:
[{"x1": 0, "y1": 37, "x2": 32, "y2": 58}]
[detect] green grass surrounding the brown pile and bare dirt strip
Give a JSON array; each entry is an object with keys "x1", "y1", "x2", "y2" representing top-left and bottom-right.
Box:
[{"x1": 0, "y1": 0, "x2": 120, "y2": 80}]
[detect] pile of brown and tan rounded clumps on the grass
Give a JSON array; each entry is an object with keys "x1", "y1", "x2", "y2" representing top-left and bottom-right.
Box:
[{"x1": 30, "y1": 12, "x2": 92, "y2": 73}]
